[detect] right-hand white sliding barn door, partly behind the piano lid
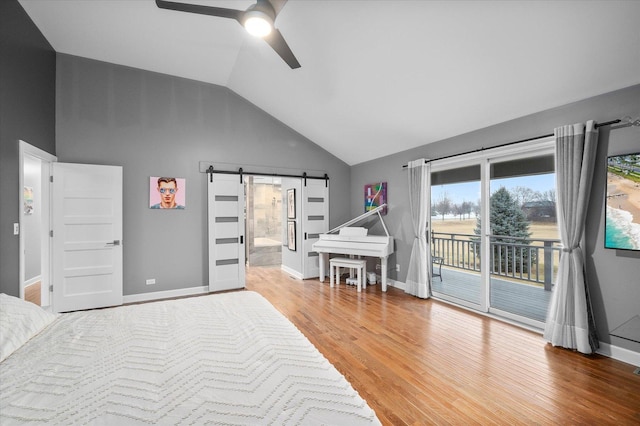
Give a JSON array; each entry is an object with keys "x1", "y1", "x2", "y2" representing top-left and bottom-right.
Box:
[{"x1": 302, "y1": 179, "x2": 329, "y2": 279}]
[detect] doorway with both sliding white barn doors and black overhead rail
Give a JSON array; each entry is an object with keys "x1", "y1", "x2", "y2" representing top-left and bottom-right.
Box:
[{"x1": 206, "y1": 166, "x2": 329, "y2": 292}]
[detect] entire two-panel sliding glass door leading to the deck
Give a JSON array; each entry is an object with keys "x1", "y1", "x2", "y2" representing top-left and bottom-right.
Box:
[{"x1": 429, "y1": 139, "x2": 560, "y2": 328}]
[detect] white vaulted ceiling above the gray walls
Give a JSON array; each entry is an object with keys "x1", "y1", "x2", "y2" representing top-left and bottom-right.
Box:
[{"x1": 20, "y1": 0, "x2": 640, "y2": 165}]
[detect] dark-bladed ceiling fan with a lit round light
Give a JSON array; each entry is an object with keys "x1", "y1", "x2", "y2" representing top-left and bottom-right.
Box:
[{"x1": 156, "y1": 0, "x2": 300, "y2": 69}]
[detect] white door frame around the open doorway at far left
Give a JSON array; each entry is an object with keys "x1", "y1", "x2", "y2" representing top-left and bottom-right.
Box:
[{"x1": 18, "y1": 140, "x2": 58, "y2": 305}]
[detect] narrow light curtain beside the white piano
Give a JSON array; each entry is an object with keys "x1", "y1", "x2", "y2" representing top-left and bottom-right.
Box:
[{"x1": 405, "y1": 158, "x2": 431, "y2": 299}]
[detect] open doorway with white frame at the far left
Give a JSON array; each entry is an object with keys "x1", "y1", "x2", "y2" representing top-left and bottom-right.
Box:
[{"x1": 18, "y1": 141, "x2": 56, "y2": 306}]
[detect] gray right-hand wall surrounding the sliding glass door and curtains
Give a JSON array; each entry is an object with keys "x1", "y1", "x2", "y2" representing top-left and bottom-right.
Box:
[{"x1": 351, "y1": 85, "x2": 640, "y2": 352}]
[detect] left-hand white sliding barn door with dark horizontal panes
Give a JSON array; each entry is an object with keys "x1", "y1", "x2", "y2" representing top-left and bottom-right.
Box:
[{"x1": 207, "y1": 173, "x2": 245, "y2": 291}]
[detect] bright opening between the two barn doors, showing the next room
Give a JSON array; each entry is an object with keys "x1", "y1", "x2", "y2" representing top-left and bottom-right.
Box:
[{"x1": 245, "y1": 176, "x2": 283, "y2": 268}]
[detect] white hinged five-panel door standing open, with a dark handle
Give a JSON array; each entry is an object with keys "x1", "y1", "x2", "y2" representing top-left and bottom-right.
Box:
[{"x1": 51, "y1": 163, "x2": 122, "y2": 312}]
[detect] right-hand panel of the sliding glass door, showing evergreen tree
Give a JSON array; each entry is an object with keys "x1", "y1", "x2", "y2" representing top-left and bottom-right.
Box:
[{"x1": 489, "y1": 154, "x2": 560, "y2": 323}]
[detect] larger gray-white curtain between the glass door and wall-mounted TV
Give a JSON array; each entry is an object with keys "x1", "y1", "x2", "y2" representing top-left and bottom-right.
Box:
[{"x1": 544, "y1": 121, "x2": 598, "y2": 354}]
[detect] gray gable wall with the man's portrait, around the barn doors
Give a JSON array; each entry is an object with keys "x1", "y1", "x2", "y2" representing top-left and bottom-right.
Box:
[{"x1": 56, "y1": 54, "x2": 350, "y2": 295}]
